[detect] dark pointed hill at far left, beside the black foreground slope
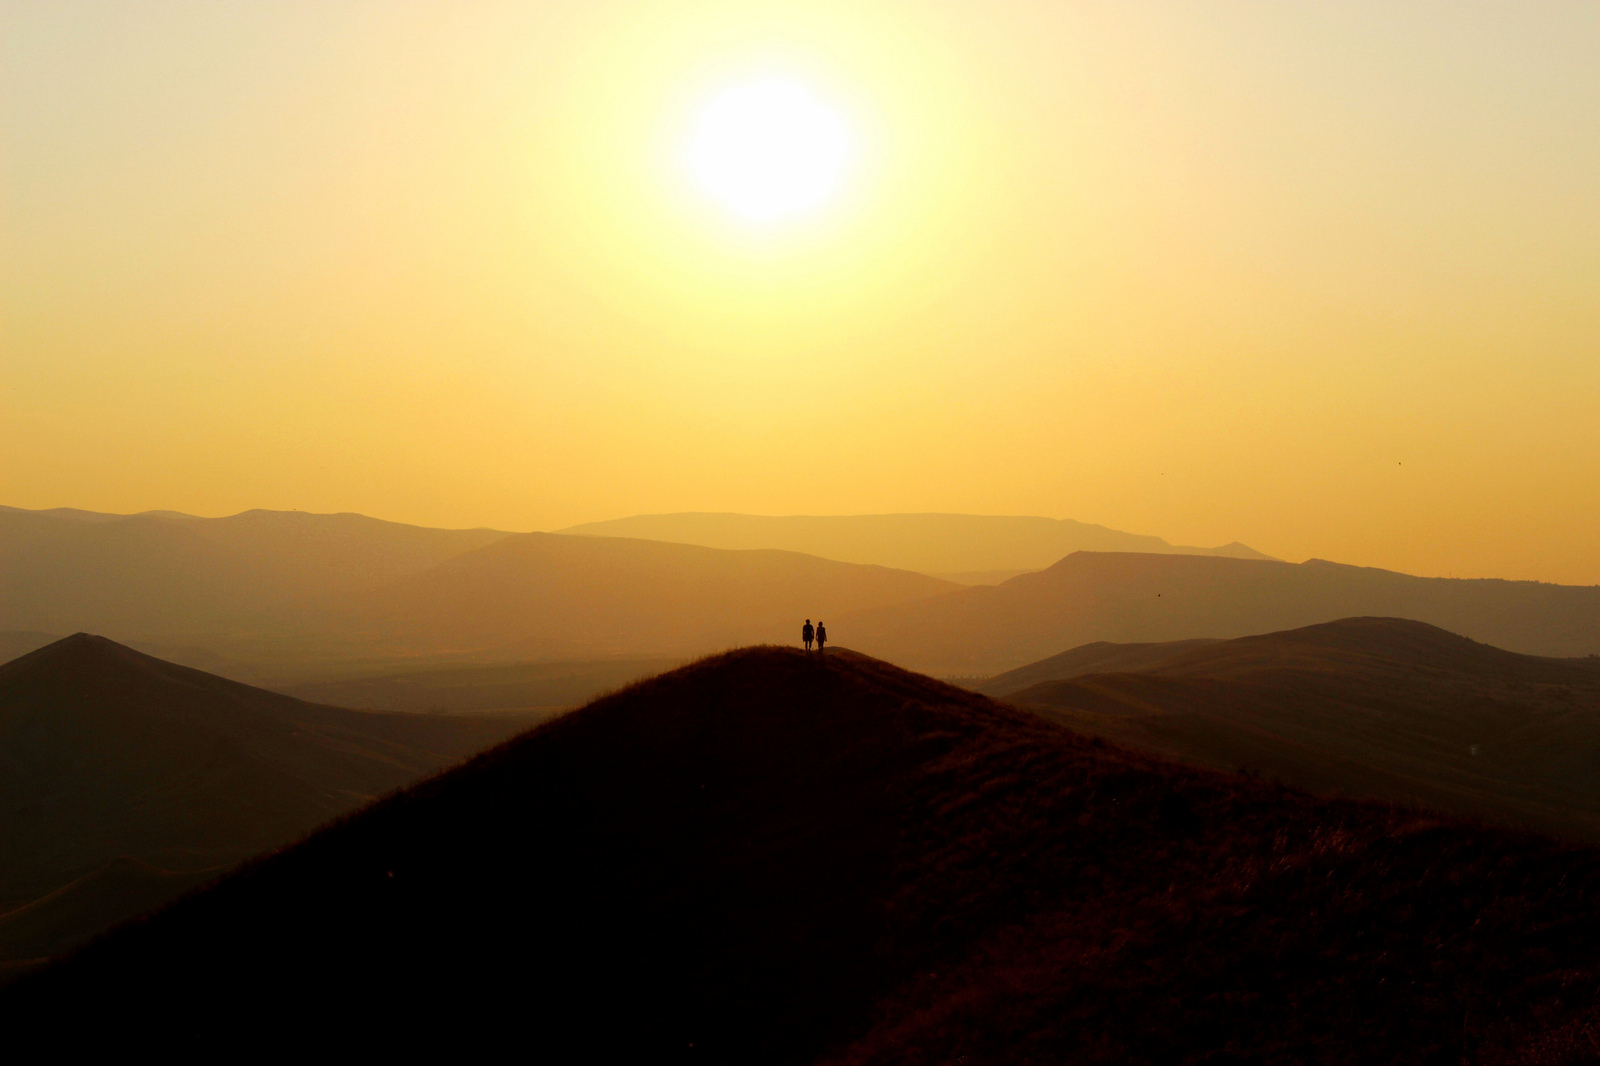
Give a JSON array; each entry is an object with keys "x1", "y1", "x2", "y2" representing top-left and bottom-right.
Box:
[{"x1": 0, "y1": 634, "x2": 537, "y2": 960}]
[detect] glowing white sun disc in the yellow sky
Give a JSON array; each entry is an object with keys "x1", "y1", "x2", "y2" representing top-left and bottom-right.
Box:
[{"x1": 683, "y1": 77, "x2": 854, "y2": 222}]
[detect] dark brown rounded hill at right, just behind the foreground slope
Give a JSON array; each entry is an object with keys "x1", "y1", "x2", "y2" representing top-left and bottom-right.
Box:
[{"x1": 997, "y1": 618, "x2": 1600, "y2": 844}]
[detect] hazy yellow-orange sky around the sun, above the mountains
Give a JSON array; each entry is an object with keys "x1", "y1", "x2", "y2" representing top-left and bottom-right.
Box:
[{"x1": 0, "y1": 0, "x2": 1600, "y2": 584}]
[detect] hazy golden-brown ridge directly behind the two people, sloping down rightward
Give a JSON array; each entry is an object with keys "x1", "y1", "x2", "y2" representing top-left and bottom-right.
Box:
[{"x1": 350, "y1": 533, "x2": 957, "y2": 658}]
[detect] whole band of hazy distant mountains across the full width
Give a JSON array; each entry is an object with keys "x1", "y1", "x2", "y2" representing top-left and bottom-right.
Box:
[{"x1": 0, "y1": 511, "x2": 1600, "y2": 675}]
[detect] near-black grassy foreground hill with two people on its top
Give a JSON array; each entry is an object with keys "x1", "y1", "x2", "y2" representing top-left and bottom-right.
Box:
[{"x1": 9, "y1": 648, "x2": 1600, "y2": 1064}]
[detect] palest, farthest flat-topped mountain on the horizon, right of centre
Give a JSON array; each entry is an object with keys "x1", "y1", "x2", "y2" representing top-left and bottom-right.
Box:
[{"x1": 562, "y1": 514, "x2": 1269, "y2": 573}]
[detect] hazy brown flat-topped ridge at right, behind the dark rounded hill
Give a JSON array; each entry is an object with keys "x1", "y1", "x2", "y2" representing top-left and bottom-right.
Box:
[{"x1": 829, "y1": 552, "x2": 1600, "y2": 675}]
